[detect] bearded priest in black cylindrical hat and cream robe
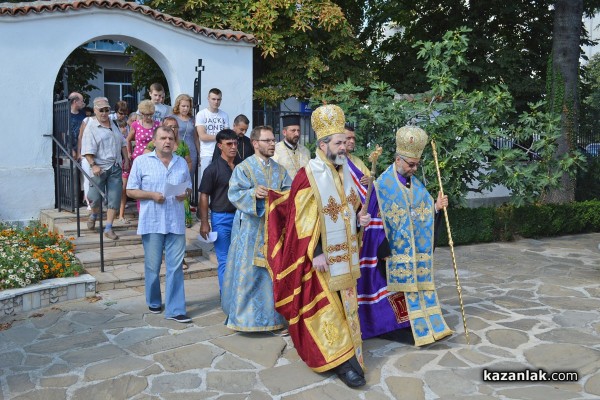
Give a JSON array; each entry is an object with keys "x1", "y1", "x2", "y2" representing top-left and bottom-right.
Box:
[{"x1": 273, "y1": 114, "x2": 310, "y2": 179}]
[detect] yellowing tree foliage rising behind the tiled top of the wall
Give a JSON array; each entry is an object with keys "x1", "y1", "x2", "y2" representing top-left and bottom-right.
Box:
[{"x1": 148, "y1": 0, "x2": 371, "y2": 104}]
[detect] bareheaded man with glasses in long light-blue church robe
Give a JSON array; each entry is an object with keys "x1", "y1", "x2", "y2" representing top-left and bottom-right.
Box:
[{"x1": 221, "y1": 126, "x2": 292, "y2": 332}]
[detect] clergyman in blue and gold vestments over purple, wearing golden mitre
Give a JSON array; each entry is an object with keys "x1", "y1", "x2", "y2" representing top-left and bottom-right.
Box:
[{"x1": 358, "y1": 126, "x2": 452, "y2": 346}]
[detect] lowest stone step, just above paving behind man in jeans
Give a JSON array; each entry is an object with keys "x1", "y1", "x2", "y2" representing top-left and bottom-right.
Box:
[{"x1": 86, "y1": 256, "x2": 217, "y2": 291}]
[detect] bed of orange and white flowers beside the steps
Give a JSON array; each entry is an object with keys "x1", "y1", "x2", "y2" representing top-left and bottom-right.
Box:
[{"x1": 0, "y1": 223, "x2": 84, "y2": 290}]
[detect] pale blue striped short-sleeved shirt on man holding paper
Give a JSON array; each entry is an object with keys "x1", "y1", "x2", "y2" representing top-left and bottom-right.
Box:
[{"x1": 127, "y1": 151, "x2": 192, "y2": 235}]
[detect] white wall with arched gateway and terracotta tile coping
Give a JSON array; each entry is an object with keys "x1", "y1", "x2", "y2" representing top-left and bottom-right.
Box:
[{"x1": 0, "y1": 0, "x2": 255, "y2": 222}]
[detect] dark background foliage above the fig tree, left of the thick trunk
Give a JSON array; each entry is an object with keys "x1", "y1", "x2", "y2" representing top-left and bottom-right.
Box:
[{"x1": 363, "y1": 0, "x2": 554, "y2": 109}]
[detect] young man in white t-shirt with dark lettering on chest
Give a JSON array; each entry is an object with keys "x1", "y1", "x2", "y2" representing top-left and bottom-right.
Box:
[{"x1": 196, "y1": 88, "x2": 229, "y2": 182}]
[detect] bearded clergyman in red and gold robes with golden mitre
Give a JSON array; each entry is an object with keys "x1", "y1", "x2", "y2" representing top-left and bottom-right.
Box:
[{"x1": 266, "y1": 104, "x2": 370, "y2": 387}]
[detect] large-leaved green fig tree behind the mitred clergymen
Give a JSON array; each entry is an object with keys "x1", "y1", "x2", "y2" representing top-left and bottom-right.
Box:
[{"x1": 315, "y1": 28, "x2": 584, "y2": 205}]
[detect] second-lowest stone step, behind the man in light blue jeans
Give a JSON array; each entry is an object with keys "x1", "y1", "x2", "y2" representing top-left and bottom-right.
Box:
[{"x1": 75, "y1": 239, "x2": 202, "y2": 270}]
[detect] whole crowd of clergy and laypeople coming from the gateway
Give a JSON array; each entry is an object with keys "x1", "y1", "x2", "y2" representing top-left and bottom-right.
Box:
[{"x1": 69, "y1": 84, "x2": 452, "y2": 387}]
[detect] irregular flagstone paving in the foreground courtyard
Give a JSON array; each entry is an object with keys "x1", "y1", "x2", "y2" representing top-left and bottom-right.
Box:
[{"x1": 0, "y1": 233, "x2": 600, "y2": 400}]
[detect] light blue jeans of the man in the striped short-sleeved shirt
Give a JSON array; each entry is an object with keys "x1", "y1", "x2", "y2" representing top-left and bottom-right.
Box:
[{"x1": 142, "y1": 233, "x2": 186, "y2": 317}]
